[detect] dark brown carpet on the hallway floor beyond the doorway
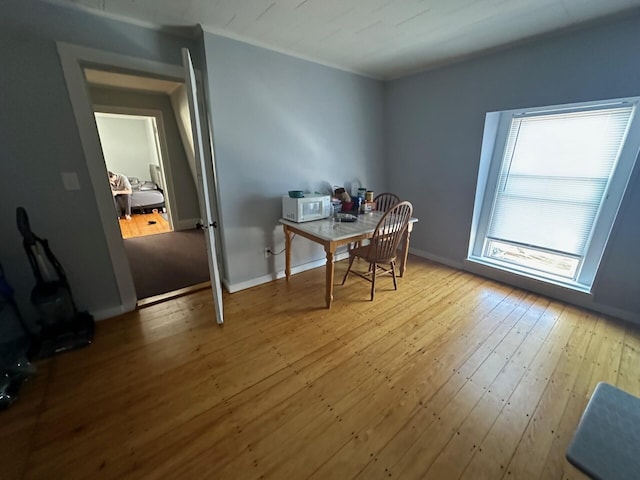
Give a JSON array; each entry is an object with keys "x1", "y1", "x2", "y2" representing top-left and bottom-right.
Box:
[{"x1": 123, "y1": 229, "x2": 209, "y2": 299}]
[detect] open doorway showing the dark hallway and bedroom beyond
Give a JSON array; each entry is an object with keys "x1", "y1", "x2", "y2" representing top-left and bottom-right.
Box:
[{"x1": 85, "y1": 71, "x2": 209, "y2": 305}]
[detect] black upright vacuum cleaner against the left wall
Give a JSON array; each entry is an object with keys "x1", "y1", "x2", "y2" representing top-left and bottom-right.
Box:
[{"x1": 16, "y1": 207, "x2": 95, "y2": 358}]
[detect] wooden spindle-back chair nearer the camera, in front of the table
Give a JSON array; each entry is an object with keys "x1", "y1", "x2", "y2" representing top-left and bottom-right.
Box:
[{"x1": 342, "y1": 202, "x2": 413, "y2": 300}]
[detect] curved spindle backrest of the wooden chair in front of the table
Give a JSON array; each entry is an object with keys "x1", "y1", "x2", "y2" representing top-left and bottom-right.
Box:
[{"x1": 367, "y1": 201, "x2": 413, "y2": 263}]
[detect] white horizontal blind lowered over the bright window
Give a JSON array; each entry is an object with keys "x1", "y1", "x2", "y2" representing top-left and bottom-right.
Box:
[{"x1": 487, "y1": 105, "x2": 634, "y2": 256}]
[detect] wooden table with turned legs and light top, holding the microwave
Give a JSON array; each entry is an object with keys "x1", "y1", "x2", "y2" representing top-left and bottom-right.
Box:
[{"x1": 280, "y1": 212, "x2": 418, "y2": 308}]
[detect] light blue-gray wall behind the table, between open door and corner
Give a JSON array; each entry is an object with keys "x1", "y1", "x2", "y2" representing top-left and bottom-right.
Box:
[{"x1": 204, "y1": 34, "x2": 387, "y2": 286}]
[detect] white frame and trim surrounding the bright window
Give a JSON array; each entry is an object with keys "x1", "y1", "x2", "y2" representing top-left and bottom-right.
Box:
[{"x1": 467, "y1": 97, "x2": 640, "y2": 292}]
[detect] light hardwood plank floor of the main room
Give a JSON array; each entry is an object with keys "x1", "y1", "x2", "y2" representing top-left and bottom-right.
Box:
[{"x1": 0, "y1": 257, "x2": 640, "y2": 480}]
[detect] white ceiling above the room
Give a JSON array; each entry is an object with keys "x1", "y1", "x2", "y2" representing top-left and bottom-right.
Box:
[{"x1": 50, "y1": 0, "x2": 640, "y2": 79}]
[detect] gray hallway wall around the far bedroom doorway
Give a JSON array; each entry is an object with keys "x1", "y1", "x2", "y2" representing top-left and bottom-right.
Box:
[{"x1": 90, "y1": 87, "x2": 200, "y2": 222}]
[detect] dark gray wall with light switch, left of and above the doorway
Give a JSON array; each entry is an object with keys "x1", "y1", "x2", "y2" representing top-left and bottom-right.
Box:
[{"x1": 0, "y1": 0, "x2": 196, "y2": 318}]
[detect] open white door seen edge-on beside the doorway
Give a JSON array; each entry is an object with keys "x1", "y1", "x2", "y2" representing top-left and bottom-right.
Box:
[{"x1": 182, "y1": 48, "x2": 223, "y2": 323}]
